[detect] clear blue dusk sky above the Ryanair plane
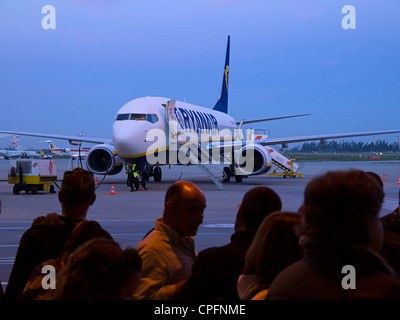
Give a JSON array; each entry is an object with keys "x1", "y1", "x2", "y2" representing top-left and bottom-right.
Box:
[{"x1": 0, "y1": 0, "x2": 400, "y2": 147}]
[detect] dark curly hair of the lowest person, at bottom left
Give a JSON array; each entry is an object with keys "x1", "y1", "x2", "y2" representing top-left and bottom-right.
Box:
[{"x1": 50, "y1": 238, "x2": 142, "y2": 300}]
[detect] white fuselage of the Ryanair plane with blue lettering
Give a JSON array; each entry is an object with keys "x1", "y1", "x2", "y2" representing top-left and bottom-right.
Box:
[{"x1": 113, "y1": 97, "x2": 237, "y2": 161}]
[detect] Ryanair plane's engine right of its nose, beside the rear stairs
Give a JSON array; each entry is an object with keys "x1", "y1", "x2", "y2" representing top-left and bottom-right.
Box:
[{"x1": 235, "y1": 144, "x2": 272, "y2": 175}]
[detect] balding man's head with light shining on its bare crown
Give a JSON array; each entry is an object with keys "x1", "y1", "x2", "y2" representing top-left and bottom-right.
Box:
[{"x1": 163, "y1": 181, "x2": 206, "y2": 236}]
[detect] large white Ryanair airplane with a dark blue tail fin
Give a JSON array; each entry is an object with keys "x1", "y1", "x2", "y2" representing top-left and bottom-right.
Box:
[{"x1": 0, "y1": 36, "x2": 400, "y2": 186}]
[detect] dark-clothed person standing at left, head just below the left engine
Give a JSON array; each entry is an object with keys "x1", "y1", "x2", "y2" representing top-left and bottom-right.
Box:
[{"x1": 5, "y1": 168, "x2": 112, "y2": 300}]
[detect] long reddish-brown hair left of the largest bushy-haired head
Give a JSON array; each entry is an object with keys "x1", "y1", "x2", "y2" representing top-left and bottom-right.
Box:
[{"x1": 243, "y1": 211, "x2": 303, "y2": 284}]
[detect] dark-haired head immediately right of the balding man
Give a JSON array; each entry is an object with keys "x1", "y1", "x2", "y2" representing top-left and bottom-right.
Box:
[{"x1": 235, "y1": 187, "x2": 282, "y2": 232}]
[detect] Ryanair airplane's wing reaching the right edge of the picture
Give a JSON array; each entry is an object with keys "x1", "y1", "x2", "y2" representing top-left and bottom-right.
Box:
[{"x1": 260, "y1": 130, "x2": 400, "y2": 146}]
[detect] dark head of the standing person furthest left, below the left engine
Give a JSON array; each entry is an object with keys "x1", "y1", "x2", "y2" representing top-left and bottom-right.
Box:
[{"x1": 58, "y1": 168, "x2": 96, "y2": 218}]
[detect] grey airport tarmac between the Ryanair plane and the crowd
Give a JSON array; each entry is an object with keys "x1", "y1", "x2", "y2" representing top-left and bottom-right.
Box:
[{"x1": 0, "y1": 159, "x2": 400, "y2": 286}]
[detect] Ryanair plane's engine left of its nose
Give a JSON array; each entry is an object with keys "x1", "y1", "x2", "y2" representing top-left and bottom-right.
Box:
[{"x1": 86, "y1": 144, "x2": 123, "y2": 175}]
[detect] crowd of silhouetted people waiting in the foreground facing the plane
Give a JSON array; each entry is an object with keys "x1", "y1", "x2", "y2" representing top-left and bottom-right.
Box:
[{"x1": 0, "y1": 168, "x2": 400, "y2": 301}]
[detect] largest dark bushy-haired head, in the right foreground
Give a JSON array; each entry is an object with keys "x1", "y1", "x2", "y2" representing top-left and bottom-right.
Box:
[{"x1": 301, "y1": 170, "x2": 384, "y2": 250}]
